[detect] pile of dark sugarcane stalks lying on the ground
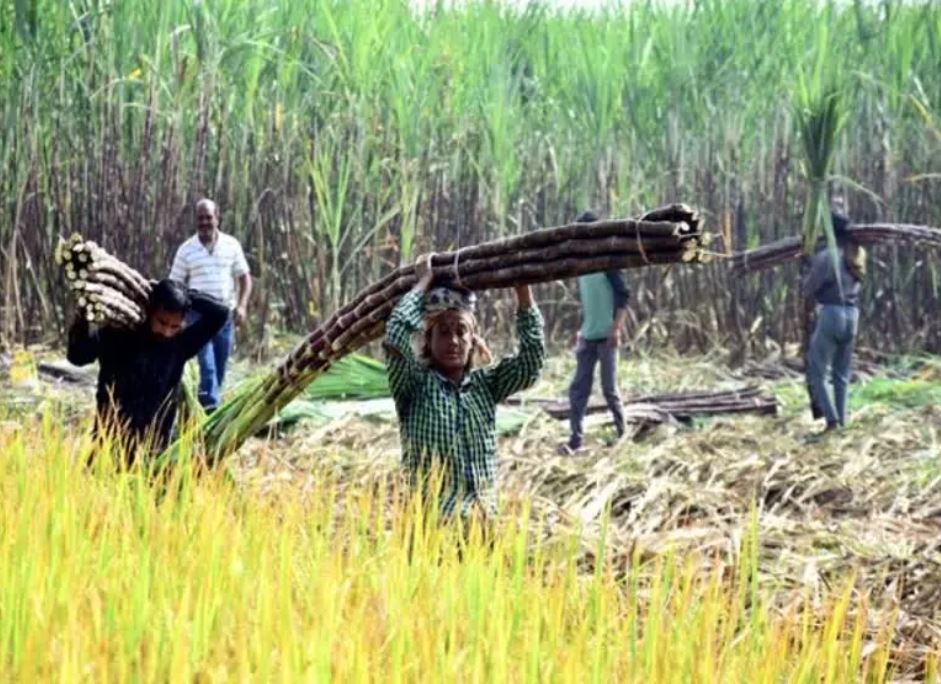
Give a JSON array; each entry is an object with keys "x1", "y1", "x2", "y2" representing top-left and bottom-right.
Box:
[{"x1": 542, "y1": 386, "x2": 778, "y2": 422}]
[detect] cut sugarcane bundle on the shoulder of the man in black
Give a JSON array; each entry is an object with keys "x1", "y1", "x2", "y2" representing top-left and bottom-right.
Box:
[{"x1": 55, "y1": 234, "x2": 150, "y2": 327}]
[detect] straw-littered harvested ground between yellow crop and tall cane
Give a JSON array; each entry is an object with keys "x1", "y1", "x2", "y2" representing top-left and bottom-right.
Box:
[{"x1": 0, "y1": 348, "x2": 941, "y2": 678}]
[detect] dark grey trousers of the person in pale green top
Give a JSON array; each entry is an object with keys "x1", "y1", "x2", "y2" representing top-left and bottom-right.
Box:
[{"x1": 569, "y1": 340, "x2": 624, "y2": 449}]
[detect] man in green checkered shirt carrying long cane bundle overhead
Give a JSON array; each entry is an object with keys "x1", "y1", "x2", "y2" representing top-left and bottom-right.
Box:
[{"x1": 384, "y1": 255, "x2": 546, "y2": 517}]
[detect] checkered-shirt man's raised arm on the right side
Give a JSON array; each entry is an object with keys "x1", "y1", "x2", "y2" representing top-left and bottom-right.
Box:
[{"x1": 484, "y1": 285, "x2": 546, "y2": 401}]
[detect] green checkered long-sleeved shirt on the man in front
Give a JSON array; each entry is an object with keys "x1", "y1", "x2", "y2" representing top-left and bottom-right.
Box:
[{"x1": 384, "y1": 292, "x2": 546, "y2": 516}]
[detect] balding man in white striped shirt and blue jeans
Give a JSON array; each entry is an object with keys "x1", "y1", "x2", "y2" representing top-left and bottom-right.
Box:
[{"x1": 170, "y1": 199, "x2": 252, "y2": 411}]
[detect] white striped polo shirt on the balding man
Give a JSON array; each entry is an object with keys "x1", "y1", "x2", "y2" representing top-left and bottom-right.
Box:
[{"x1": 170, "y1": 231, "x2": 248, "y2": 308}]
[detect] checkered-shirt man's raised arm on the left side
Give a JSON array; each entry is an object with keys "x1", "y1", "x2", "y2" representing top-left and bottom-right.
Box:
[{"x1": 382, "y1": 254, "x2": 434, "y2": 410}]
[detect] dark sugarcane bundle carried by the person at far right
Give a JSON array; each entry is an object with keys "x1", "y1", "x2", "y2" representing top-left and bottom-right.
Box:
[{"x1": 732, "y1": 223, "x2": 941, "y2": 273}]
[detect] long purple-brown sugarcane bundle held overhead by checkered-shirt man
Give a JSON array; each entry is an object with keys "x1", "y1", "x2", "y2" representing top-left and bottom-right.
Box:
[{"x1": 178, "y1": 204, "x2": 705, "y2": 460}]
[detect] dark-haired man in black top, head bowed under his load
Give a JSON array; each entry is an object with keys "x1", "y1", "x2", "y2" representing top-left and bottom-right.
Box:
[{"x1": 68, "y1": 279, "x2": 229, "y2": 464}]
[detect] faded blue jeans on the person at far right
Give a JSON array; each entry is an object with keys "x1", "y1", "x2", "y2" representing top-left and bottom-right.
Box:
[{"x1": 807, "y1": 304, "x2": 859, "y2": 426}]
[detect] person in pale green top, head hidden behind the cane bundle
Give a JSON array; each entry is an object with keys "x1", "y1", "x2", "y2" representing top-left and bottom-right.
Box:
[{"x1": 560, "y1": 211, "x2": 629, "y2": 454}]
